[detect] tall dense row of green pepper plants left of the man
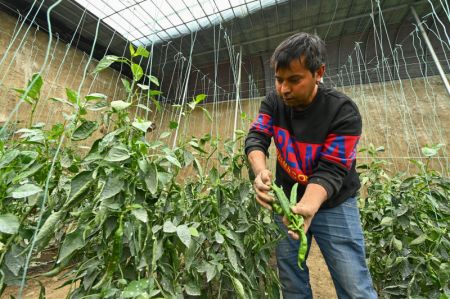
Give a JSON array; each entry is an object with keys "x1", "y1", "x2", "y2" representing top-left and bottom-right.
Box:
[{"x1": 0, "y1": 46, "x2": 279, "y2": 298}]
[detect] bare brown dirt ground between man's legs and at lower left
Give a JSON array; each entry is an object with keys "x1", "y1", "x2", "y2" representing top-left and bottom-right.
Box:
[{"x1": 1, "y1": 241, "x2": 337, "y2": 299}]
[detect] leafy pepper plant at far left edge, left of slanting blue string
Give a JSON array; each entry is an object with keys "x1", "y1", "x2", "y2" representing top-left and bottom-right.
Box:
[{"x1": 0, "y1": 74, "x2": 72, "y2": 290}]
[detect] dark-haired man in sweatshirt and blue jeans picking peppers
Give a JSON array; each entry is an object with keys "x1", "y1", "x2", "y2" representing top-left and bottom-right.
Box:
[{"x1": 245, "y1": 33, "x2": 377, "y2": 299}]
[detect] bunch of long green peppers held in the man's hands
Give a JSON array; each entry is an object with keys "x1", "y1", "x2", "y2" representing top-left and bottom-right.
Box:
[{"x1": 272, "y1": 183, "x2": 308, "y2": 270}]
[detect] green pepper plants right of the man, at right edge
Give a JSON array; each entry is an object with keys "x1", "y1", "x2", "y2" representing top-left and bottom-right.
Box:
[{"x1": 358, "y1": 145, "x2": 450, "y2": 298}]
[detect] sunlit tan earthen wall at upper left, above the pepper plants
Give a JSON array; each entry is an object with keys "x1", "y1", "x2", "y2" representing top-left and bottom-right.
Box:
[{"x1": 0, "y1": 11, "x2": 125, "y2": 145}]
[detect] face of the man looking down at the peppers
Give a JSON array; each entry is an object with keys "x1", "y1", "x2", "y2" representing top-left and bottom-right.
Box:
[{"x1": 275, "y1": 57, "x2": 325, "y2": 109}]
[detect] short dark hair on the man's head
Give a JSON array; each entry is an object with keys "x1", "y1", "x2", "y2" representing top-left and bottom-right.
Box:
[{"x1": 270, "y1": 32, "x2": 326, "y2": 73}]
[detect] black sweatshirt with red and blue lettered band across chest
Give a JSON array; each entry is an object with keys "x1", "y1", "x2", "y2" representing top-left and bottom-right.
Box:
[{"x1": 245, "y1": 84, "x2": 362, "y2": 208}]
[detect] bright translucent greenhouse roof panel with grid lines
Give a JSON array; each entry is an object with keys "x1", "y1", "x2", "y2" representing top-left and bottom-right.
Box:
[{"x1": 74, "y1": 0, "x2": 287, "y2": 45}]
